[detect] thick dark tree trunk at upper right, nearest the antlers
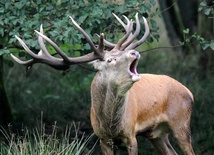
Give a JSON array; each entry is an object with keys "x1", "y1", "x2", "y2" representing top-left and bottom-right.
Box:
[{"x1": 159, "y1": 0, "x2": 197, "y2": 55}]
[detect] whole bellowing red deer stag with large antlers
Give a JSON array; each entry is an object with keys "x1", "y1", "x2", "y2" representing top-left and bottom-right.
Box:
[{"x1": 11, "y1": 14, "x2": 194, "y2": 155}]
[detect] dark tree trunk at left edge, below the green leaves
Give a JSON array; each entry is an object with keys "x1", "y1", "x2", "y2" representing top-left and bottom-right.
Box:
[{"x1": 0, "y1": 55, "x2": 12, "y2": 127}]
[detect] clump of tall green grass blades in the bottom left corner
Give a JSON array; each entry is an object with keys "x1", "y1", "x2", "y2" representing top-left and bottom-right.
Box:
[{"x1": 0, "y1": 121, "x2": 95, "y2": 155}]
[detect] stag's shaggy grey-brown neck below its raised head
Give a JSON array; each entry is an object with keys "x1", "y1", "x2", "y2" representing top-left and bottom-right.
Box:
[{"x1": 91, "y1": 73, "x2": 132, "y2": 131}]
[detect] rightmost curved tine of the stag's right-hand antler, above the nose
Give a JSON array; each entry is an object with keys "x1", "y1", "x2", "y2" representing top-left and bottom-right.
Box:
[{"x1": 126, "y1": 17, "x2": 150, "y2": 50}]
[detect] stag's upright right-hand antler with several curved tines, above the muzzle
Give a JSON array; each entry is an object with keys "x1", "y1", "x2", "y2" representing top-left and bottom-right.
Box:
[{"x1": 98, "y1": 13, "x2": 149, "y2": 50}]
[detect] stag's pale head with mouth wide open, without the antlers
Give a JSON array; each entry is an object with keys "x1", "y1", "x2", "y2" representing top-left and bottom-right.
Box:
[{"x1": 92, "y1": 50, "x2": 140, "y2": 85}]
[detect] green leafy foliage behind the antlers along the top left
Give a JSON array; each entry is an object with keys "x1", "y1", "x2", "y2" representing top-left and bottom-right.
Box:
[{"x1": 0, "y1": 0, "x2": 159, "y2": 58}]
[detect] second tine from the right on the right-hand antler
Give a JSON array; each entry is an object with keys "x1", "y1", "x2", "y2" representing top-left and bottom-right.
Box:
[{"x1": 121, "y1": 13, "x2": 140, "y2": 50}]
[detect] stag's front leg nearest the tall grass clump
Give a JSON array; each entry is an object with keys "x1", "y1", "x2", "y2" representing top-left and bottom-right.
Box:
[{"x1": 100, "y1": 140, "x2": 114, "y2": 155}]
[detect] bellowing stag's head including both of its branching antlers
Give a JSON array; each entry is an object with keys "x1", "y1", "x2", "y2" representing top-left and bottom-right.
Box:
[{"x1": 11, "y1": 14, "x2": 149, "y2": 84}]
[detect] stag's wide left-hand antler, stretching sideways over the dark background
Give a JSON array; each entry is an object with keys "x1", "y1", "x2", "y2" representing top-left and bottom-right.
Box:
[{"x1": 11, "y1": 16, "x2": 104, "y2": 70}]
